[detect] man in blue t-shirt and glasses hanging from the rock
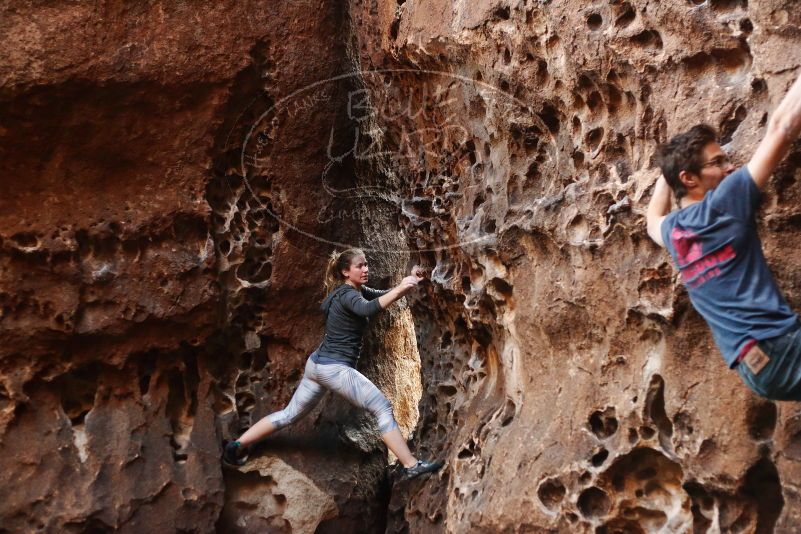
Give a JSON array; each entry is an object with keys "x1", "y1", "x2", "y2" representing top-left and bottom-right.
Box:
[{"x1": 647, "y1": 70, "x2": 801, "y2": 400}]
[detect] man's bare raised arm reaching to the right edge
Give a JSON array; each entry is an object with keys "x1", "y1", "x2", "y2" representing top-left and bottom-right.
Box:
[{"x1": 748, "y1": 72, "x2": 801, "y2": 189}]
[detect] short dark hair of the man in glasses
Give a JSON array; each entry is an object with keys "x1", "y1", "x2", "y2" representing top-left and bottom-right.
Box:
[{"x1": 656, "y1": 124, "x2": 718, "y2": 200}]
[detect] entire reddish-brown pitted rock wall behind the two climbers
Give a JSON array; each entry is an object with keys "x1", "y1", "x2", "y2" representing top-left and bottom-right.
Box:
[{"x1": 0, "y1": 0, "x2": 801, "y2": 533}]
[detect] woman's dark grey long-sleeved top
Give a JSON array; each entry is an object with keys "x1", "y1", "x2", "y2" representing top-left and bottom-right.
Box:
[{"x1": 312, "y1": 284, "x2": 389, "y2": 367}]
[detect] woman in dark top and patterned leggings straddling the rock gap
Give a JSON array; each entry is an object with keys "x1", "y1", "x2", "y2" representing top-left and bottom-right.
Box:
[{"x1": 223, "y1": 249, "x2": 443, "y2": 479}]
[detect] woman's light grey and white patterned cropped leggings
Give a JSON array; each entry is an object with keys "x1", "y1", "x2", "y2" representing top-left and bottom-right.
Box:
[{"x1": 267, "y1": 358, "x2": 398, "y2": 434}]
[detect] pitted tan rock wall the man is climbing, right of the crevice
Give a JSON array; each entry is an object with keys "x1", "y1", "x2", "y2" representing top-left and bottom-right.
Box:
[{"x1": 352, "y1": 0, "x2": 801, "y2": 532}]
